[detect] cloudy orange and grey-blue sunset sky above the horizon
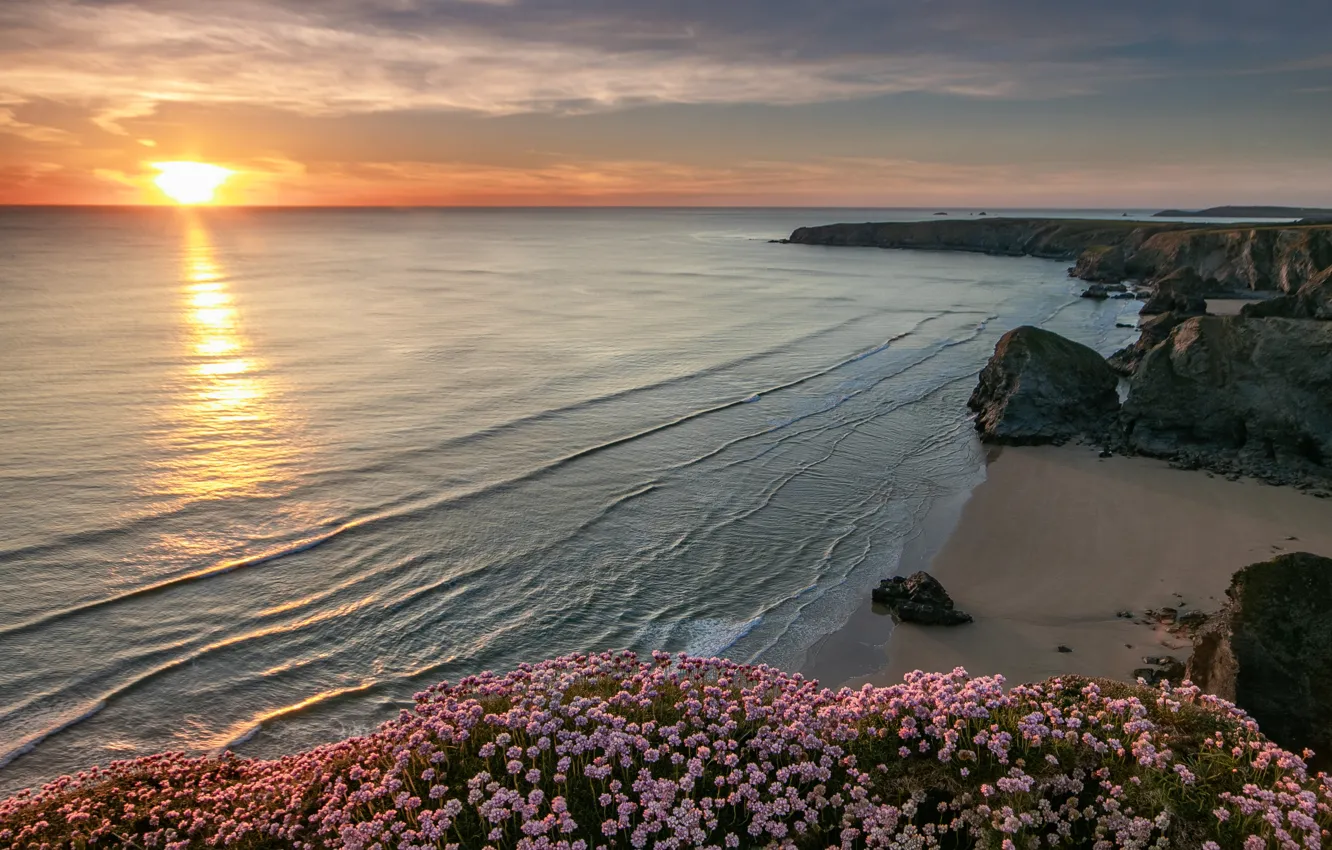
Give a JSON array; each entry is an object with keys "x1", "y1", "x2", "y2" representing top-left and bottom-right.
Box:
[{"x1": 0, "y1": 0, "x2": 1332, "y2": 209}]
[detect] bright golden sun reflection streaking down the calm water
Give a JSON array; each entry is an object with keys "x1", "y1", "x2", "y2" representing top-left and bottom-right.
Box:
[{"x1": 157, "y1": 218, "x2": 294, "y2": 498}]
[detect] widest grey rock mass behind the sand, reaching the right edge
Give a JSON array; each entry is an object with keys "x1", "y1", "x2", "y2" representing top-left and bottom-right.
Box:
[{"x1": 1120, "y1": 316, "x2": 1332, "y2": 481}]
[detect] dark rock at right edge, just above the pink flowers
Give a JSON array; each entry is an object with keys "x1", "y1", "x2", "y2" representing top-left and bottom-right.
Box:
[{"x1": 1188, "y1": 553, "x2": 1332, "y2": 766}]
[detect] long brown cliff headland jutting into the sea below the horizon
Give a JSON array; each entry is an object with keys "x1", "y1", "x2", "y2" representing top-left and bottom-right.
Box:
[{"x1": 786, "y1": 218, "x2": 1332, "y2": 293}]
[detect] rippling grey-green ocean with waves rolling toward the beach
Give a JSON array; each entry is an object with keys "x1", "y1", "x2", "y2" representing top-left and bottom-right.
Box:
[{"x1": 0, "y1": 208, "x2": 1138, "y2": 793}]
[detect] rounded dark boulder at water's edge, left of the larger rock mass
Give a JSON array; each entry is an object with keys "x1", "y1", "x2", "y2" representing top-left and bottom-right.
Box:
[{"x1": 967, "y1": 325, "x2": 1119, "y2": 445}]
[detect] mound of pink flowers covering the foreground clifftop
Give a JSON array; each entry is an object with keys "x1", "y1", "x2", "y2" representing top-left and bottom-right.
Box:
[{"x1": 0, "y1": 653, "x2": 1332, "y2": 850}]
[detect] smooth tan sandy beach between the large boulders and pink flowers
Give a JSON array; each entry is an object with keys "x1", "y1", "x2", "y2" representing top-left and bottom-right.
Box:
[{"x1": 803, "y1": 446, "x2": 1332, "y2": 685}]
